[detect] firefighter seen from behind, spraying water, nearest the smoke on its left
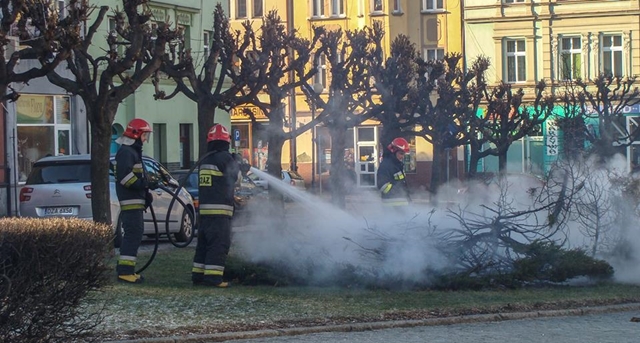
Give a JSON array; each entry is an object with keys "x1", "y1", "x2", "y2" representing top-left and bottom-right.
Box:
[{"x1": 191, "y1": 124, "x2": 240, "y2": 288}]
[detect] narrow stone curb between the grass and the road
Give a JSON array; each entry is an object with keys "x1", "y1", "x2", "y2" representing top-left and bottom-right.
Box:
[{"x1": 105, "y1": 303, "x2": 640, "y2": 343}]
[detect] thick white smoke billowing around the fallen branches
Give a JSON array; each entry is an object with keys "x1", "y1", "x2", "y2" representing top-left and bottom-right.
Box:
[{"x1": 232, "y1": 158, "x2": 640, "y2": 283}]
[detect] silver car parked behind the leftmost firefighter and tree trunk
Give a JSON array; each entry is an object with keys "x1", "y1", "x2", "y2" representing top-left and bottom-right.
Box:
[{"x1": 20, "y1": 154, "x2": 195, "y2": 242}]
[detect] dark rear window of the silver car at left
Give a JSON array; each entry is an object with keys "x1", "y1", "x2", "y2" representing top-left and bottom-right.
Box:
[{"x1": 27, "y1": 161, "x2": 94, "y2": 185}]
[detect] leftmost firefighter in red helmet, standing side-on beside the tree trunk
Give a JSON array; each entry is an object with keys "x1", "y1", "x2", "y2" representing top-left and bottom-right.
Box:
[{"x1": 115, "y1": 118, "x2": 157, "y2": 283}]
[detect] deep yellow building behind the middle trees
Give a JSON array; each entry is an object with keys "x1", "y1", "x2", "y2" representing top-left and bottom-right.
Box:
[{"x1": 229, "y1": 0, "x2": 463, "y2": 188}]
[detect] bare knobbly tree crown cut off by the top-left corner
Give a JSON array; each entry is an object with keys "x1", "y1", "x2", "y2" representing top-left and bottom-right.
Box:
[{"x1": 0, "y1": 0, "x2": 90, "y2": 102}]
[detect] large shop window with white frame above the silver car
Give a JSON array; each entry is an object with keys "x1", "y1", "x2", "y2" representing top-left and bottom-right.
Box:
[{"x1": 16, "y1": 94, "x2": 73, "y2": 181}]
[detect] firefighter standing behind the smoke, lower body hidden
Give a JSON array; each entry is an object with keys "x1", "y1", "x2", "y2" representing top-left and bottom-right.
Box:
[{"x1": 377, "y1": 137, "x2": 409, "y2": 206}]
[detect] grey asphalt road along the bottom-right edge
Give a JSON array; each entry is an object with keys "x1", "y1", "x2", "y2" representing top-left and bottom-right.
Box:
[{"x1": 228, "y1": 311, "x2": 640, "y2": 343}]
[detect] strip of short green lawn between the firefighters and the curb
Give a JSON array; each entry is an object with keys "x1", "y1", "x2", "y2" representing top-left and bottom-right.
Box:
[{"x1": 92, "y1": 248, "x2": 640, "y2": 339}]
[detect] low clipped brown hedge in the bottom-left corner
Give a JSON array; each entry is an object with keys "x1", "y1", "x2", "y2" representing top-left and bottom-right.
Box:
[{"x1": 0, "y1": 218, "x2": 112, "y2": 343}]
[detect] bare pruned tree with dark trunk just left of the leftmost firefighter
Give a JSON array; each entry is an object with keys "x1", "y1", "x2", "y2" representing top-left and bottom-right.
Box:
[{"x1": 47, "y1": 0, "x2": 179, "y2": 224}]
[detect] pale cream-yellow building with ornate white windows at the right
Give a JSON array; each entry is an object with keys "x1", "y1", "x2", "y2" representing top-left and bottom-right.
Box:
[{"x1": 464, "y1": 0, "x2": 640, "y2": 175}]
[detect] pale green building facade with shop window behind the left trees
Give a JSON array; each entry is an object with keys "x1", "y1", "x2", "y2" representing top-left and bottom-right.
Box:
[{"x1": 0, "y1": 0, "x2": 225, "y2": 216}]
